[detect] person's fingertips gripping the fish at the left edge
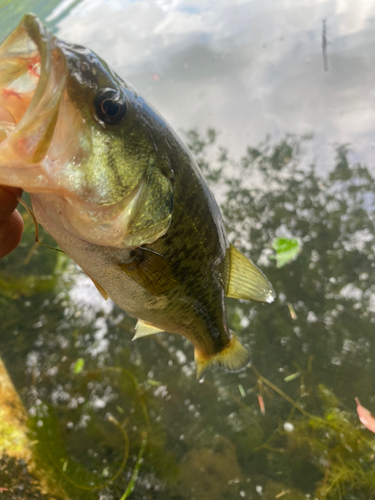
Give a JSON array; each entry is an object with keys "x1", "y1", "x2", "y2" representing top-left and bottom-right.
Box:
[{"x1": 0, "y1": 186, "x2": 23, "y2": 259}]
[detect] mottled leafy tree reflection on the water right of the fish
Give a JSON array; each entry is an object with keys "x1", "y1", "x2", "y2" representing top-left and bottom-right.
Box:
[{"x1": 212, "y1": 137, "x2": 375, "y2": 398}]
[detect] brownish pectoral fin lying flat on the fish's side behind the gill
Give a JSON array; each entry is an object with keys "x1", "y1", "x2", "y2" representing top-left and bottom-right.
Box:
[{"x1": 120, "y1": 247, "x2": 178, "y2": 295}]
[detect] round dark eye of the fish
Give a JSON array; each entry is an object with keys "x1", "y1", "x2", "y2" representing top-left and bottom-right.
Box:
[{"x1": 94, "y1": 88, "x2": 127, "y2": 125}]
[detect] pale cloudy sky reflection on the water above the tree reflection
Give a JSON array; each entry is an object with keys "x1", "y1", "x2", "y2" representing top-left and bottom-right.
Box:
[{"x1": 47, "y1": 0, "x2": 375, "y2": 171}]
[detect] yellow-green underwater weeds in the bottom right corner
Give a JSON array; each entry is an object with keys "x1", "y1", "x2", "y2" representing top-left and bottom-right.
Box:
[{"x1": 247, "y1": 368, "x2": 375, "y2": 499}]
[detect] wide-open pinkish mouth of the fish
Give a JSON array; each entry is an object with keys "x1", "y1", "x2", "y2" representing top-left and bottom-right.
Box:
[{"x1": 0, "y1": 14, "x2": 64, "y2": 164}]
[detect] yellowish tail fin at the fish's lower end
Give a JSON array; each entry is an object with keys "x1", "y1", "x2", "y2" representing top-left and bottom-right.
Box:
[{"x1": 194, "y1": 333, "x2": 250, "y2": 380}]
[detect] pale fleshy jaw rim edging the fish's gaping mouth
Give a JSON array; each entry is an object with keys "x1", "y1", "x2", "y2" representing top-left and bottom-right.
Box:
[{"x1": 0, "y1": 14, "x2": 66, "y2": 170}]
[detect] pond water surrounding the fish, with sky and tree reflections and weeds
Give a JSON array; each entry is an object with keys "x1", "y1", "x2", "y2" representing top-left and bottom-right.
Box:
[{"x1": 0, "y1": 0, "x2": 375, "y2": 500}]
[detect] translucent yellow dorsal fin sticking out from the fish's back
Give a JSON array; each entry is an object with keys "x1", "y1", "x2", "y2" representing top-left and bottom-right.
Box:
[{"x1": 226, "y1": 245, "x2": 276, "y2": 304}]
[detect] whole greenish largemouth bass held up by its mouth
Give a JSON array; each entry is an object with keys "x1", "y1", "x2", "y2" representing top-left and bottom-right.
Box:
[{"x1": 0, "y1": 14, "x2": 275, "y2": 378}]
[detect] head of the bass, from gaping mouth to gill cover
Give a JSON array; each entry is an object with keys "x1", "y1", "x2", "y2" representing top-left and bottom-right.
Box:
[{"x1": 0, "y1": 14, "x2": 174, "y2": 248}]
